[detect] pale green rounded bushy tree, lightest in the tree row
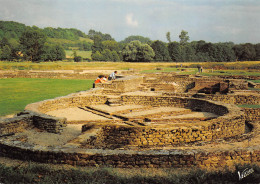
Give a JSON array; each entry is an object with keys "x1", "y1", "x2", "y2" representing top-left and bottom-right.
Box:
[{"x1": 122, "y1": 40, "x2": 155, "y2": 62}]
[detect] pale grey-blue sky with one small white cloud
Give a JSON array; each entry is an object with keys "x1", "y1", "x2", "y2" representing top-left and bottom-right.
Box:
[{"x1": 0, "y1": 0, "x2": 260, "y2": 44}]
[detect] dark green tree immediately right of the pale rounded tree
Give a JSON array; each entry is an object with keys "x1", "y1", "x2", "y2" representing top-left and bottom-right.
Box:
[{"x1": 151, "y1": 40, "x2": 171, "y2": 61}]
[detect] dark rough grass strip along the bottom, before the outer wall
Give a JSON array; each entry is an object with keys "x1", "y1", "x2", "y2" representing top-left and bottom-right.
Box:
[{"x1": 0, "y1": 164, "x2": 260, "y2": 184}]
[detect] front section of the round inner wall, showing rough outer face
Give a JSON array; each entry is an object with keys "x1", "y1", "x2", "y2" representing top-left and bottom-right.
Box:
[{"x1": 89, "y1": 119, "x2": 245, "y2": 149}]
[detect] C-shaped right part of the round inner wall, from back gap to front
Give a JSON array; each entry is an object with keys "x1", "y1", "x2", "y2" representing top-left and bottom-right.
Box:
[{"x1": 83, "y1": 95, "x2": 245, "y2": 148}]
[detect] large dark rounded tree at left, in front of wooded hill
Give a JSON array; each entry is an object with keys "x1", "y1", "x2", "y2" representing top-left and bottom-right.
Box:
[{"x1": 20, "y1": 29, "x2": 46, "y2": 61}]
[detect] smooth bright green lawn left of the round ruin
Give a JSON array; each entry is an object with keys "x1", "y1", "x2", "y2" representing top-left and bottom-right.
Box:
[{"x1": 0, "y1": 78, "x2": 93, "y2": 116}]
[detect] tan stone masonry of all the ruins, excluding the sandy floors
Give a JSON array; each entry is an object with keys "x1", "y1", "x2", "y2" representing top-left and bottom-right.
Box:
[{"x1": 0, "y1": 71, "x2": 260, "y2": 168}]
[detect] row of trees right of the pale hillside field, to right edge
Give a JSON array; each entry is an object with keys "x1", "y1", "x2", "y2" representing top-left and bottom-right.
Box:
[{"x1": 92, "y1": 30, "x2": 260, "y2": 62}]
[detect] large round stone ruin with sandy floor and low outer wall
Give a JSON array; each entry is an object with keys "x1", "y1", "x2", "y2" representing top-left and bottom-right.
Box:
[{"x1": 0, "y1": 73, "x2": 260, "y2": 168}]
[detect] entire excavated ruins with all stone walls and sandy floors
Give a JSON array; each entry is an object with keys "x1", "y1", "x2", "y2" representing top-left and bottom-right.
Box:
[{"x1": 0, "y1": 71, "x2": 260, "y2": 168}]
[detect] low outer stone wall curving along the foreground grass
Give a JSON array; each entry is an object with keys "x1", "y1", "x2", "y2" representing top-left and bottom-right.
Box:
[{"x1": 0, "y1": 140, "x2": 260, "y2": 169}]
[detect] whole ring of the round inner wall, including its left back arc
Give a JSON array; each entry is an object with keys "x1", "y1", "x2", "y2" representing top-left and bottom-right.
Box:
[{"x1": 21, "y1": 92, "x2": 245, "y2": 148}]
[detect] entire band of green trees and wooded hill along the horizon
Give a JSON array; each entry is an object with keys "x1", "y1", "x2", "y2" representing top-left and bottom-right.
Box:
[{"x1": 0, "y1": 21, "x2": 260, "y2": 62}]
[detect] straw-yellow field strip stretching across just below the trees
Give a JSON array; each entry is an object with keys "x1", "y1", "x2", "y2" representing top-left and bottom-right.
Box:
[{"x1": 0, "y1": 60, "x2": 260, "y2": 76}]
